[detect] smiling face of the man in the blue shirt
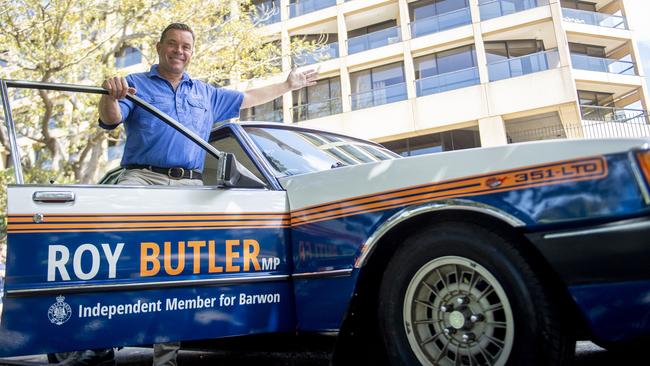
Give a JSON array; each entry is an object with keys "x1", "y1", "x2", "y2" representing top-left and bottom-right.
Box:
[{"x1": 156, "y1": 29, "x2": 194, "y2": 74}]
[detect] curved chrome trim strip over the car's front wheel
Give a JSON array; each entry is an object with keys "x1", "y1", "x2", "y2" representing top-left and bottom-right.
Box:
[{"x1": 354, "y1": 199, "x2": 525, "y2": 268}]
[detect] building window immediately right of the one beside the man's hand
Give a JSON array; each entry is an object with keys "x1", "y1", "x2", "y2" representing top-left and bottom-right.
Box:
[{"x1": 350, "y1": 62, "x2": 406, "y2": 109}]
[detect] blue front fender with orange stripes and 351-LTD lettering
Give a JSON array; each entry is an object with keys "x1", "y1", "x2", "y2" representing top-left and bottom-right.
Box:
[{"x1": 288, "y1": 154, "x2": 647, "y2": 330}]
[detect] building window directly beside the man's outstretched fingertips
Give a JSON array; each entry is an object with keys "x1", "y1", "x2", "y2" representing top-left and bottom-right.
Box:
[{"x1": 293, "y1": 77, "x2": 342, "y2": 122}]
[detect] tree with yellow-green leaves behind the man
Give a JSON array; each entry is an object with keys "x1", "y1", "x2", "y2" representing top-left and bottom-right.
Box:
[{"x1": 0, "y1": 0, "x2": 318, "y2": 264}]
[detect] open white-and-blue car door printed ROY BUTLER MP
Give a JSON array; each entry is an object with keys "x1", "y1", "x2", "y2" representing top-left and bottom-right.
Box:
[{"x1": 0, "y1": 80, "x2": 294, "y2": 357}]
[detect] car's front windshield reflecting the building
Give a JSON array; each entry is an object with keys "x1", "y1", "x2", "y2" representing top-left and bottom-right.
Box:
[{"x1": 245, "y1": 127, "x2": 400, "y2": 176}]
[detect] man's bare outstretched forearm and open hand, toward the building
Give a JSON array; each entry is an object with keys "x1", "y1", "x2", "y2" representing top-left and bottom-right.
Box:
[{"x1": 241, "y1": 67, "x2": 318, "y2": 108}]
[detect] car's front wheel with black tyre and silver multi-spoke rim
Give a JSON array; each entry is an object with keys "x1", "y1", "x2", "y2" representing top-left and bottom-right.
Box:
[{"x1": 378, "y1": 223, "x2": 575, "y2": 365}]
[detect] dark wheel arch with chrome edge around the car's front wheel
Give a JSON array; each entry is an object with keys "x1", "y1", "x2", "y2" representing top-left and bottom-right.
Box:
[{"x1": 334, "y1": 200, "x2": 588, "y2": 364}]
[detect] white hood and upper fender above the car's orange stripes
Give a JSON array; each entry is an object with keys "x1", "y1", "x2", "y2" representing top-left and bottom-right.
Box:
[{"x1": 280, "y1": 138, "x2": 650, "y2": 210}]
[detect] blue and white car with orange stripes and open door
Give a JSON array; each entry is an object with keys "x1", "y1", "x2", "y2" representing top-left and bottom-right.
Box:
[{"x1": 0, "y1": 83, "x2": 650, "y2": 365}]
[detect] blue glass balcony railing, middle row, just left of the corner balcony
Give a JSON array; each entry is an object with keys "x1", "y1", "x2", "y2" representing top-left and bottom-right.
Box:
[{"x1": 488, "y1": 49, "x2": 560, "y2": 81}]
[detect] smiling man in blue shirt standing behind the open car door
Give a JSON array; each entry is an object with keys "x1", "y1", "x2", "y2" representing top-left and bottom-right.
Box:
[{"x1": 99, "y1": 23, "x2": 318, "y2": 365}]
